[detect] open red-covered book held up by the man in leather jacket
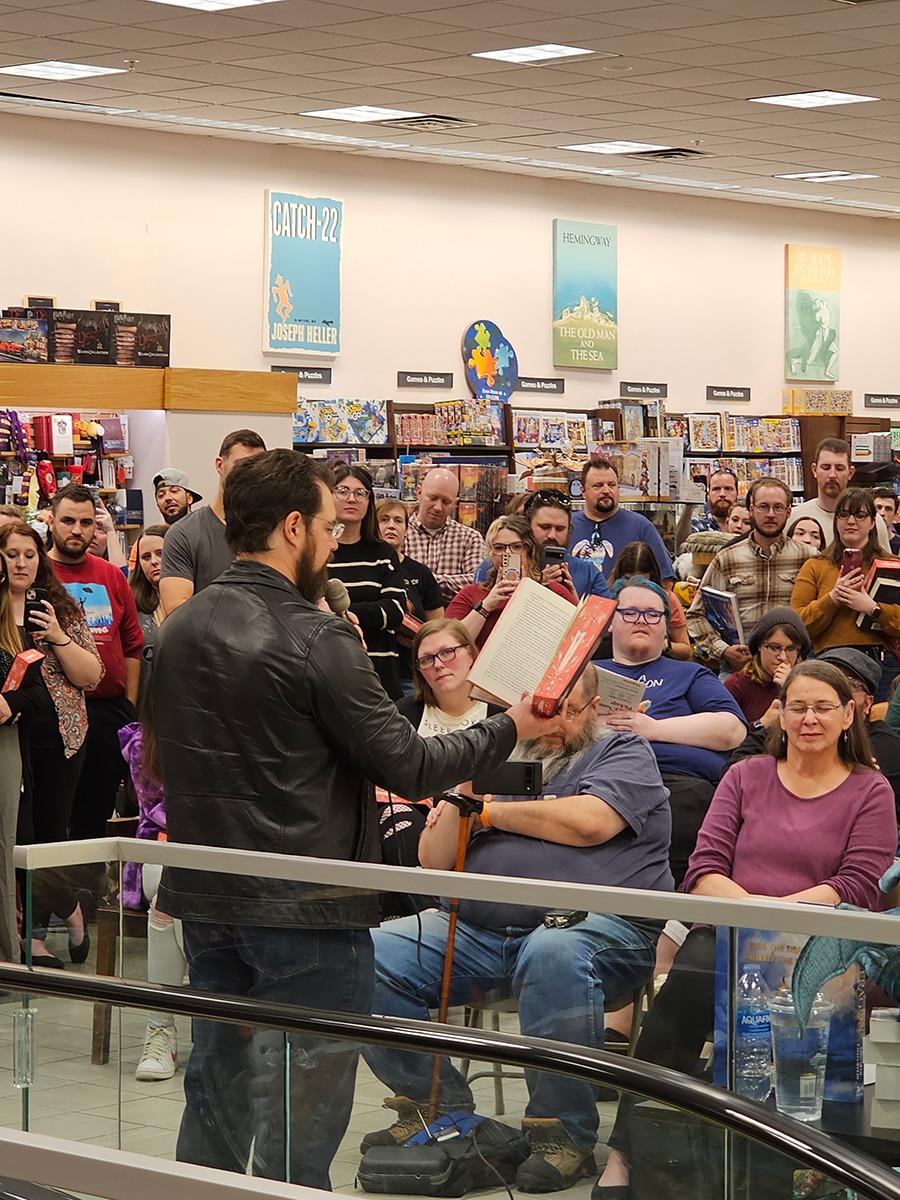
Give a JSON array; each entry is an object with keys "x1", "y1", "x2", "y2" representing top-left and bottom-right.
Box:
[{"x1": 469, "y1": 578, "x2": 616, "y2": 716}]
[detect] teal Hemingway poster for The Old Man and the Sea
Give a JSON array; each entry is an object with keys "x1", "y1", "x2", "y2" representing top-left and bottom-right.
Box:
[{"x1": 553, "y1": 220, "x2": 619, "y2": 371}]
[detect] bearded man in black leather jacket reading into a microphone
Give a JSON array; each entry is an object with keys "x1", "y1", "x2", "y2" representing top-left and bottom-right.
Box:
[{"x1": 152, "y1": 450, "x2": 563, "y2": 1188}]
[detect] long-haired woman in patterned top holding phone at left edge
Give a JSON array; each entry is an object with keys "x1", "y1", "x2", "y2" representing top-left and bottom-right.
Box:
[{"x1": 0, "y1": 521, "x2": 104, "y2": 967}]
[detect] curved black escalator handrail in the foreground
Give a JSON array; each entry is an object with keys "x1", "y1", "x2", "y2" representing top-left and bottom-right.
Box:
[{"x1": 0, "y1": 962, "x2": 900, "y2": 1200}]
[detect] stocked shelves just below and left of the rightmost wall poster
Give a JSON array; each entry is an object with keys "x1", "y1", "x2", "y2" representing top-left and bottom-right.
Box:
[{"x1": 681, "y1": 413, "x2": 803, "y2": 503}]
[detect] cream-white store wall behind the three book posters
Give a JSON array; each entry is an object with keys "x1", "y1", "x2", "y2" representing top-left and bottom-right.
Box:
[{"x1": 0, "y1": 115, "x2": 900, "y2": 491}]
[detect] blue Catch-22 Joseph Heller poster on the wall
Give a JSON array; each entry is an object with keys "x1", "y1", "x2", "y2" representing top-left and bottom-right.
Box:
[{"x1": 263, "y1": 191, "x2": 343, "y2": 354}]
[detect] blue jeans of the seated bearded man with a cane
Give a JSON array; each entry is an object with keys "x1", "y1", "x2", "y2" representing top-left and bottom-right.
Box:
[{"x1": 362, "y1": 912, "x2": 656, "y2": 1153}]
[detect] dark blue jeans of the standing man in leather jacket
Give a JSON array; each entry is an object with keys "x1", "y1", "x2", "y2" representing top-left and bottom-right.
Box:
[{"x1": 175, "y1": 920, "x2": 373, "y2": 1190}]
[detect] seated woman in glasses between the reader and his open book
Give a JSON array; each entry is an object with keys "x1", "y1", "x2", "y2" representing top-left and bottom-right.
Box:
[{"x1": 376, "y1": 617, "x2": 503, "y2": 918}]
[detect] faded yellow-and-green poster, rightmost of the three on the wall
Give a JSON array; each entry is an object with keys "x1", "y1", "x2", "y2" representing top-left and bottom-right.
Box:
[{"x1": 785, "y1": 245, "x2": 841, "y2": 383}]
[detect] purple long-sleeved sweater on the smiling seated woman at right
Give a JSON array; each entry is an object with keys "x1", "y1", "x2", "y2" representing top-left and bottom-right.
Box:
[{"x1": 684, "y1": 755, "x2": 896, "y2": 911}]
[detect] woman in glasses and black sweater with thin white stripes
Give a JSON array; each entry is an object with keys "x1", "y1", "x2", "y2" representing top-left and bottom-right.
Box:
[{"x1": 328, "y1": 462, "x2": 407, "y2": 700}]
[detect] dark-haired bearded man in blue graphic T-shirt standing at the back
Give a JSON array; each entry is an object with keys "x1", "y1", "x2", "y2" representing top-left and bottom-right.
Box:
[{"x1": 569, "y1": 458, "x2": 674, "y2": 588}]
